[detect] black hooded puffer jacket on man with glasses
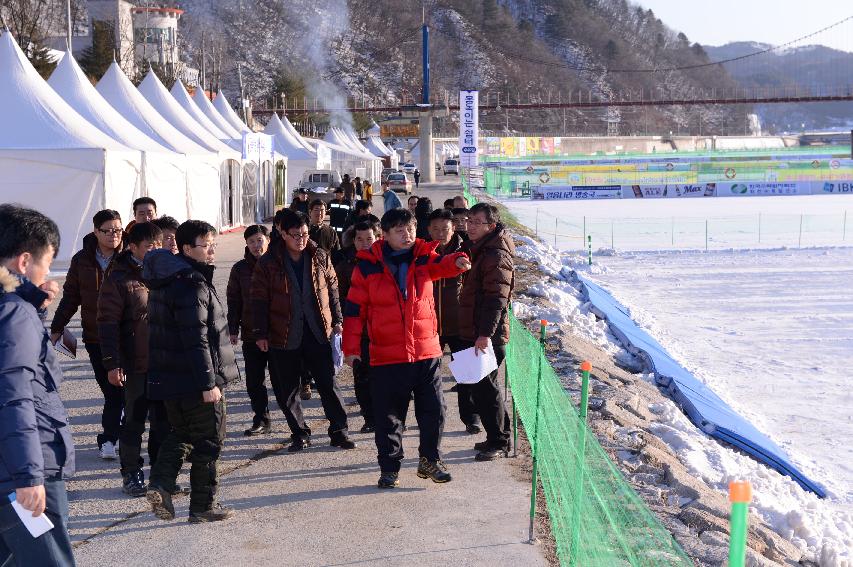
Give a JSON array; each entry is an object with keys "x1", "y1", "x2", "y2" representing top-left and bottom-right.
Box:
[{"x1": 143, "y1": 250, "x2": 239, "y2": 400}]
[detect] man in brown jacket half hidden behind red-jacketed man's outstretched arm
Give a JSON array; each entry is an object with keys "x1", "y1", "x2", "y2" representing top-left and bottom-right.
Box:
[{"x1": 427, "y1": 209, "x2": 482, "y2": 435}]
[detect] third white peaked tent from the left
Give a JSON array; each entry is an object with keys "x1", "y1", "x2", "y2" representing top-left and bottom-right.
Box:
[{"x1": 97, "y1": 62, "x2": 223, "y2": 228}]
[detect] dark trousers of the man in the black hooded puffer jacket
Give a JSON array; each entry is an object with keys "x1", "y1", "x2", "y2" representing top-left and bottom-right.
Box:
[{"x1": 150, "y1": 392, "x2": 225, "y2": 513}]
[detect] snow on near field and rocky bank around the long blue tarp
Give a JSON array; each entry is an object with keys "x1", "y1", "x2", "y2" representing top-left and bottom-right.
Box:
[{"x1": 515, "y1": 233, "x2": 853, "y2": 566}]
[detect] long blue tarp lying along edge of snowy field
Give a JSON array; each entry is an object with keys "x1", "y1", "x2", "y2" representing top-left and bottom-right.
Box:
[{"x1": 575, "y1": 272, "x2": 826, "y2": 498}]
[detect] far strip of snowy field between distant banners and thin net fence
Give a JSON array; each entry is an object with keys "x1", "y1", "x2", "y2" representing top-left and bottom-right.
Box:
[{"x1": 506, "y1": 195, "x2": 853, "y2": 250}]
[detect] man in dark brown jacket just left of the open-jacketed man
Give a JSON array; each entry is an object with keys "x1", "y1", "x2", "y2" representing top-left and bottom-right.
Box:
[{"x1": 226, "y1": 224, "x2": 270, "y2": 436}]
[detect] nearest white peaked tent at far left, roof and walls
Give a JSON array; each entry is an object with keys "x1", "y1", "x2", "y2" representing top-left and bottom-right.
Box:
[{"x1": 0, "y1": 31, "x2": 142, "y2": 260}]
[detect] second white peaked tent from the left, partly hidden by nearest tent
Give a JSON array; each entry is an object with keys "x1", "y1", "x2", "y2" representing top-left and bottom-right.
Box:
[{"x1": 48, "y1": 54, "x2": 187, "y2": 221}]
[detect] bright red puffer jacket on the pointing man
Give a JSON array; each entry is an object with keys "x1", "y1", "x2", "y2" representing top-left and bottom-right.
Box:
[{"x1": 343, "y1": 239, "x2": 465, "y2": 366}]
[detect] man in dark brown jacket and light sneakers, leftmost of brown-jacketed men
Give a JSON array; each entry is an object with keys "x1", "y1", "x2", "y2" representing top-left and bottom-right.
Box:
[{"x1": 50, "y1": 209, "x2": 124, "y2": 460}]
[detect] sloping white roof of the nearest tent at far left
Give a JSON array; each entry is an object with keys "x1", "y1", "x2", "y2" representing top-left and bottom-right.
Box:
[{"x1": 0, "y1": 31, "x2": 130, "y2": 151}]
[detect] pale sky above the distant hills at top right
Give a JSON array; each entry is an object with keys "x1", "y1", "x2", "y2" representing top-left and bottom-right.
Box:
[{"x1": 633, "y1": 0, "x2": 853, "y2": 52}]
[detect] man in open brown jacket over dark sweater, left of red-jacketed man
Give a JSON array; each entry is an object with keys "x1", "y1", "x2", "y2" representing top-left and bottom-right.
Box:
[{"x1": 251, "y1": 209, "x2": 355, "y2": 452}]
